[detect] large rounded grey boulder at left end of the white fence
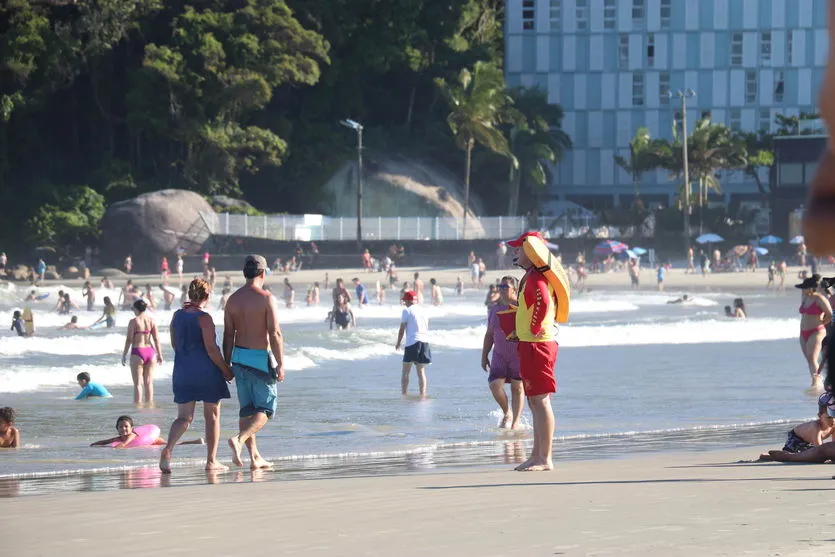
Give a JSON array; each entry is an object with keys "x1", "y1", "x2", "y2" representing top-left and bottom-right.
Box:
[{"x1": 99, "y1": 190, "x2": 214, "y2": 271}]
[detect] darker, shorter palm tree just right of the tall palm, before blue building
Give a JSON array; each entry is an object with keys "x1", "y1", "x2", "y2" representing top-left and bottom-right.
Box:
[{"x1": 508, "y1": 88, "x2": 571, "y2": 216}]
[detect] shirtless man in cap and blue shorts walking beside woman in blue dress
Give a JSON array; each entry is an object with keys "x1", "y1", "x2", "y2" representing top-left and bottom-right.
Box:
[{"x1": 223, "y1": 255, "x2": 284, "y2": 470}]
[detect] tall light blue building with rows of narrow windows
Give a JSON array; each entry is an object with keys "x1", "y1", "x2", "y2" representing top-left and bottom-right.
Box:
[{"x1": 505, "y1": 0, "x2": 829, "y2": 208}]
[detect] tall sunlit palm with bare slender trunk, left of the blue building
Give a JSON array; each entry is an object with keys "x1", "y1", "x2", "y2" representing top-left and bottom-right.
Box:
[{"x1": 436, "y1": 62, "x2": 514, "y2": 238}]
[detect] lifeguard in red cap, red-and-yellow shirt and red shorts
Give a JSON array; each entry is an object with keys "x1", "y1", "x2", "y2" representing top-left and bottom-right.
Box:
[{"x1": 508, "y1": 232, "x2": 559, "y2": 472}]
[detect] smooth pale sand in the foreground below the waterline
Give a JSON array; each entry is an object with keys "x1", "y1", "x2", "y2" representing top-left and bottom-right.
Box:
[{"x1": 8, "y1": 447, "x2": 835, "y2": 557}]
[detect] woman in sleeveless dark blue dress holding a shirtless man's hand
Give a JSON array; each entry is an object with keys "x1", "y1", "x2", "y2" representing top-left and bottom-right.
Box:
[{"x1": 159, "y1": 279, "x2": 233, "y2": 473}]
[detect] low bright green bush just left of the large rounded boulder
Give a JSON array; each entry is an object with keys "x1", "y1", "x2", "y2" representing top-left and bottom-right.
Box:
[{"x1": 24, "y1": 186, "x2": 105, "y2": 249}]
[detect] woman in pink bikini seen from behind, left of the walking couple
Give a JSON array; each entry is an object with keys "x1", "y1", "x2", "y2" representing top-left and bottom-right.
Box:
[{"x1": 122, "y1": 300, "x2": 162, "y2": 404}]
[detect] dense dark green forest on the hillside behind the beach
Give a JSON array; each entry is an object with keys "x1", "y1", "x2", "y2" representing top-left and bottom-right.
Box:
[{"x1": 0, "y1": 0, "x2": 536, "y2": 248}]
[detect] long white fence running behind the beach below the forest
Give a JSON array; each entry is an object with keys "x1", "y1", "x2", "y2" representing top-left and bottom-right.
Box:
[{"x1": 202, "y1": 213, "x2": 554, "y2": 242}]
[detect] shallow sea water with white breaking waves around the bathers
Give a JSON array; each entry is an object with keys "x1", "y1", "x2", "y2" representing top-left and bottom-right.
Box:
[{"x1": 0, "y1": 278, "x2": 816, "y2": 495}]
